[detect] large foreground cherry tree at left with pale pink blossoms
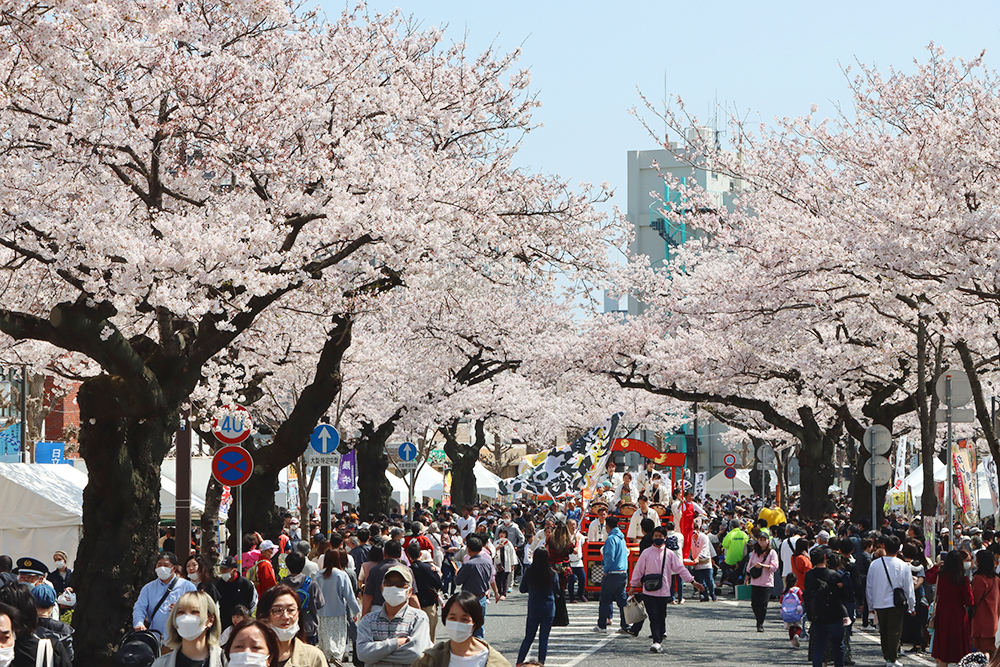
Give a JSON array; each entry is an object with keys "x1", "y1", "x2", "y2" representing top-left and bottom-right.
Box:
[{"x1": 0, "y1": 0, "x2": 617, "y2": 665}]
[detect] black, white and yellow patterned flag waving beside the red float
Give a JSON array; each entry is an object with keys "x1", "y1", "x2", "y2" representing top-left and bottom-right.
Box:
[{"x1": 499, "y1": 412, "x2": 625, "y2": 498}]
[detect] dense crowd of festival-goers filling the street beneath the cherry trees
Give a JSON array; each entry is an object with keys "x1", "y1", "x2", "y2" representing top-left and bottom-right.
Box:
[{"x1": 0, "y1": 456, "x2": 1000, "y2": 667}]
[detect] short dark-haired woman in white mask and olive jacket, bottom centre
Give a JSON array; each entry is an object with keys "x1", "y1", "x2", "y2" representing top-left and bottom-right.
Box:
[{"x1": 413, "y1": 591, "x2": 510, "y2": 667}]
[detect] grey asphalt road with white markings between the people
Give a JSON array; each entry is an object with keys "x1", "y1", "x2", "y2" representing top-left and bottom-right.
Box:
[{"x1": 474, "y1": 587, "x2": 934, "y2": 667}]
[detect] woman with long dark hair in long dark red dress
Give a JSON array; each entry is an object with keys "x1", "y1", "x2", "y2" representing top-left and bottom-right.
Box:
[{"x1": 927, "y1": 549, "x2": 973, "y2": 667}]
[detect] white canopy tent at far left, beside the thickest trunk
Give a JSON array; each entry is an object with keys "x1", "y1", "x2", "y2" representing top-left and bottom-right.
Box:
[{"x1": 0, "y1": 463, "x2": 87, "y2": 566}]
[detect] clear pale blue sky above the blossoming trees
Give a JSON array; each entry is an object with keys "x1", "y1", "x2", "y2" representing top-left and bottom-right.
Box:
[{"x1": 320, "y1": 0, "x2": 1000, "y2": 214}]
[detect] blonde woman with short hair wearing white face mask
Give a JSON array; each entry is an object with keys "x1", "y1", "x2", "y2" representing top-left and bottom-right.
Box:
[{"x1": 153, "y1": 591, "x2": 222, "y2": 667}]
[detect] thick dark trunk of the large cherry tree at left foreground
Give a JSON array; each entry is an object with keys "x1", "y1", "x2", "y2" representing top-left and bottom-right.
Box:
[{"x1": 73, "y1": 375, "x2": 179, "y2": 667}]
